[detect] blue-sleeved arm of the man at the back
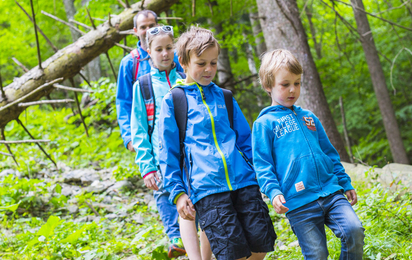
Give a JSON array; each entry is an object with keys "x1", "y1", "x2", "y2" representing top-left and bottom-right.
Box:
[{"x1": 116, "y1": 55, "x2": 133, "y2": 148}]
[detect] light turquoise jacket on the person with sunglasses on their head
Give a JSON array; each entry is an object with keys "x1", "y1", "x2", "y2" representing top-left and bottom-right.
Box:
[{"x1": 131, "y1": 67, "x2": 181, "y2": 177}]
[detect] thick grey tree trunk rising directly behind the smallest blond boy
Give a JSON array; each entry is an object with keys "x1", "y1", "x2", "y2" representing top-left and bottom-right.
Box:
[{"x1": 257, "y1": 0, "x2": 349, "y2": 162}]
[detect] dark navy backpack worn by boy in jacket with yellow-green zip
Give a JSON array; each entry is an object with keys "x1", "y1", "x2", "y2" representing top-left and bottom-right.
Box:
[{"x1": 170, "y1": 87, "x2": 233, "y2": 197}]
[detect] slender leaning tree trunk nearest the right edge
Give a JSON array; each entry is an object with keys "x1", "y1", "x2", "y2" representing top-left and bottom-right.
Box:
[{"x1": 351, "y1": 0, "x2": 409, "y2": 164}]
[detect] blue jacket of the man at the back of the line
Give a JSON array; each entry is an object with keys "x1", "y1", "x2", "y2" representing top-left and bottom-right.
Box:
[{"x1": 116, "y1": 41, "x2": 183, "y2": 147}]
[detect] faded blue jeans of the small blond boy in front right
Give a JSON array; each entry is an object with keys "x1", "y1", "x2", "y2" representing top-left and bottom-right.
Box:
[{"x1": 286, "y1": 191, "x2": 365, "y2": 260}]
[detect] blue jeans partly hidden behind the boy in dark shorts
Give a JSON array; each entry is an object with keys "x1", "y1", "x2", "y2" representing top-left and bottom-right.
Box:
[{"x1": 153, "y1": 172, "x2": 180, "y2": 240}]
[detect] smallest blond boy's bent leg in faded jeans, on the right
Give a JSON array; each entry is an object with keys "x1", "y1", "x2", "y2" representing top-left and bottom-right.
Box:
[{"x1": 325, "y1": 193, "x2": 365, "y2": 260}]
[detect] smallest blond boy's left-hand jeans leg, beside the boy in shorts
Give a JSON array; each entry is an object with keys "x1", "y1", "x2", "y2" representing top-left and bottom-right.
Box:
[{"x1": 286, "y1": 199, "x2": 329, "y2": 260}]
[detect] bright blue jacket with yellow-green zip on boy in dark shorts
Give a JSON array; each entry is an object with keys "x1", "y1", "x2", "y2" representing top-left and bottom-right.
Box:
[{"x1": 159, "y1": 81, "x2": 257, "y2": 203}]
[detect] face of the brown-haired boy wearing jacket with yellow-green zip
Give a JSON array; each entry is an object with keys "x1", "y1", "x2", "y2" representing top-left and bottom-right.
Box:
[{"x1": 182, "y1": 46, "x2": 219, "y2": 86}]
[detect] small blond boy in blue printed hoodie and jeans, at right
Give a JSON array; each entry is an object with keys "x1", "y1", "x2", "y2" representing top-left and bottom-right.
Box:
[{"x1": 252, "y1": 50, "x2": 364, "y2": 260}]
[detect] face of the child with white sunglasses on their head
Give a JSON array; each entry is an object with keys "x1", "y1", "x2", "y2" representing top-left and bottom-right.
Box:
[{"x1": 147, "y1": 35, "x2": 174, "y2": 71}]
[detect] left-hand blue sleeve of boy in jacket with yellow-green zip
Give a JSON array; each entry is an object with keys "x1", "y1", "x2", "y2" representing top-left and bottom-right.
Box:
[{"x1": 159, "y1": 92, "x2": 186, "y2": 204}]
